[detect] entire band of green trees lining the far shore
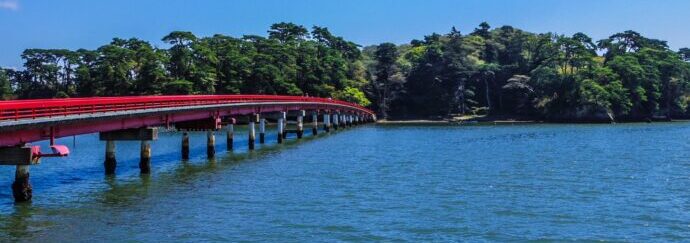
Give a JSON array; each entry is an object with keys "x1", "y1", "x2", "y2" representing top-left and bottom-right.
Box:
[{"x1": 0, "y1": 23, "x2": 690, "y2": 122}]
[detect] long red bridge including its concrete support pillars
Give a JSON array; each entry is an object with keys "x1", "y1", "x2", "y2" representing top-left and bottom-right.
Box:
[{"x1": 0, "y1": 95, "x2": 376, "y2": 201}]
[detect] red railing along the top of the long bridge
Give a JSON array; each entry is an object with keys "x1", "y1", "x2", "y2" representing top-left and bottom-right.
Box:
[{"x1": 0, "y1": 95, "x2": 373, "y2": 121}]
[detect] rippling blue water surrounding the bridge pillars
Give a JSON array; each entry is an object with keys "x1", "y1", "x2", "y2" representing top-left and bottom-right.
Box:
[{"x1": 0, "y1": 123, "x2": 690, "y2": 242}]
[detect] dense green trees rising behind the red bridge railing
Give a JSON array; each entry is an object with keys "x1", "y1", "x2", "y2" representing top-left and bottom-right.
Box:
[{"x1": 0, "y1": 23, "x2": 370, "y2": 105}]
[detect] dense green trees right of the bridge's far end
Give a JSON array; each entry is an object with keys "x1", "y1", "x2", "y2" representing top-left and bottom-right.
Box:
[{"x1": 363, "y1": 23, "x2": 690, "y2": 121}]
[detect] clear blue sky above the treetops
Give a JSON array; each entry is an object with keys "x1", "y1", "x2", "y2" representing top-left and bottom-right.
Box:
[{"x1": 0, "y1": 0, "x2": 690, "y2": 67}]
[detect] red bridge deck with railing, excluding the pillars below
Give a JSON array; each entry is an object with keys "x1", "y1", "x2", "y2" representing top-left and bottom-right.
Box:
[{"x1": 0, "y1": 95, "x2": 373, "y2": 147}]
